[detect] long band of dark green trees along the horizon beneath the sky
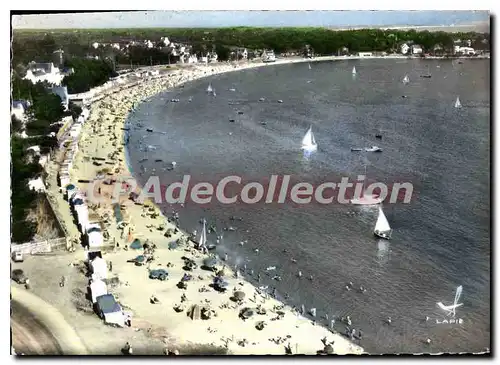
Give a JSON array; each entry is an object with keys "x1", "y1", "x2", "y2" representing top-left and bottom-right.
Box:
[{"x1": 12, "y1": 27, "x2": 490, "y2": 65}]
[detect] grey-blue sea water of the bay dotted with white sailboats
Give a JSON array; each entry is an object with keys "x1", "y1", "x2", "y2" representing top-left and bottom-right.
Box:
[{"x1": 128, "y1": 59, "x2": 491, "y2": 353}]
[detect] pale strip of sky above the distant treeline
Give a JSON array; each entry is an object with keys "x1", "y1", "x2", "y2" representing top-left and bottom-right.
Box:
[{"x1": 12, "y1": 10, "x2": 489, "y2": 29}]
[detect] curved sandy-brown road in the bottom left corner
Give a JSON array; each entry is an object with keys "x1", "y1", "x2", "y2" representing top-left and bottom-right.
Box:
[{"x1": 11, "y1": 286, "x2": 88, "y2": 355}]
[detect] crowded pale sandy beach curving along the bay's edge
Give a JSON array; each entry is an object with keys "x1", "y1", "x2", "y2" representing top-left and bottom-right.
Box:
[{"x1": 54, "y1": 63, "x2": 363, "y2": 355}]
